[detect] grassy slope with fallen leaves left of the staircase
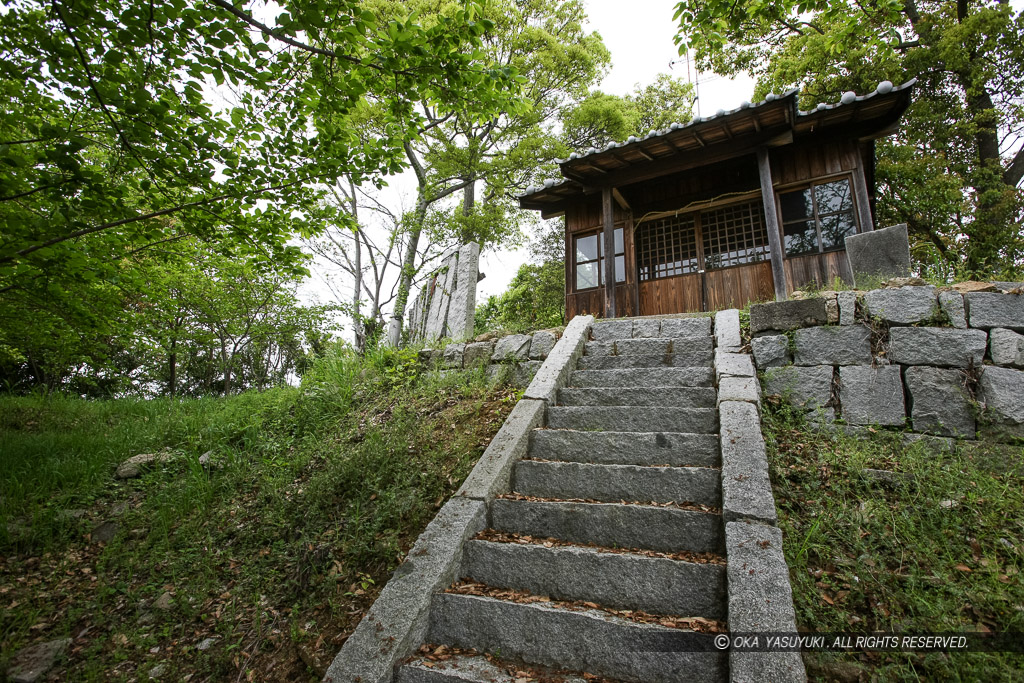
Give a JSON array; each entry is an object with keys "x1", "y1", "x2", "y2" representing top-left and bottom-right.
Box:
[{"x1": 0, "y1": 351, "x2": 516, "y2": 681}]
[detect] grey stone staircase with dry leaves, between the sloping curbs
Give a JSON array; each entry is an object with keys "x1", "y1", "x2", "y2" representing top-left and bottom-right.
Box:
[{"x1": 396, "y1": 317, "x2": 728, "y2": 683}]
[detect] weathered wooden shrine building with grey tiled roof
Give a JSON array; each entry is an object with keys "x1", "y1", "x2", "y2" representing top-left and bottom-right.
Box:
[{"x1": 519, "y1": 81, "x2": 914, "y2": 318}]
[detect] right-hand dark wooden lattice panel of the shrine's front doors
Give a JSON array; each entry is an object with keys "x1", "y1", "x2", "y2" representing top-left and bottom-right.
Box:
[{"x1": 700, "y1": 201, "x2": 771, "y2": 270}]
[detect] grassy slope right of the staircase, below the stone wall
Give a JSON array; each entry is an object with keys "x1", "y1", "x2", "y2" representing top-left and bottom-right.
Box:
[{"x1": 764, "y1": 404, "x2": 1024, "y2": 681}]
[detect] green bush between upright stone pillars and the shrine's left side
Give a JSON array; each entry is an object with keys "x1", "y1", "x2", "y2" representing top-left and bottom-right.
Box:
[{"x1": 474, "y1": 261, "x2": 565, "y2": 333}]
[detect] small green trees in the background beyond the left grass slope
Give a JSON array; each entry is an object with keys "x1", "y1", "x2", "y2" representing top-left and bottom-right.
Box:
[{"x1": 0, "y1": 240, "x2": 337, "y2": 396}]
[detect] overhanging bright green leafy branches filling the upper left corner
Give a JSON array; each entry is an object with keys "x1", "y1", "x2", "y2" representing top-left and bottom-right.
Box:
[{"x1": 0, "y1": 0, "x2": 527, "y2": 359}]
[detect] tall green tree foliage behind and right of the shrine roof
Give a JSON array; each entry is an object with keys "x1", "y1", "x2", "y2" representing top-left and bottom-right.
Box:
[{"x1": 676, "y1": 0, "x2": 1024, "y2": 276}]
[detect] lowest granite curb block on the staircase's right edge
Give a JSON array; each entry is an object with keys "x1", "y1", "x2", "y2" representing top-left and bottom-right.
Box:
[{"x1": 725, "y1": 522, "x2": 807, "y2": 683}]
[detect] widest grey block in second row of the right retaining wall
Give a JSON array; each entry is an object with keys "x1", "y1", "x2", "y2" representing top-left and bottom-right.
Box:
[{"x1": 889, "y1": 328, "x2": 988, "y2": 368}]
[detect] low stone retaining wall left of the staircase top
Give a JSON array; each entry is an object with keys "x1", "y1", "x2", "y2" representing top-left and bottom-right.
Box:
[{"x1": 420, "y1": 328, "x2": 562, "y2": 387}]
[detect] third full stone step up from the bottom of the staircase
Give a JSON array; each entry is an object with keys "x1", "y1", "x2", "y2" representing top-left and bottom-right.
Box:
[{"x1": 490, "y1": 498, "x2": 724, "y2": 553}]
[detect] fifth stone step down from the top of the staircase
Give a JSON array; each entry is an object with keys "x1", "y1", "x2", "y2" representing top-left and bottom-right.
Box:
[{"x1": 548, "y1": 405, "x2": 718, "y2": 433}]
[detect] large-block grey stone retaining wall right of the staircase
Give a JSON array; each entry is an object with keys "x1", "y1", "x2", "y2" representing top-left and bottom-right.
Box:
[{"x1": 751, "y1": 284, "x2": 1024, "y2": 439}]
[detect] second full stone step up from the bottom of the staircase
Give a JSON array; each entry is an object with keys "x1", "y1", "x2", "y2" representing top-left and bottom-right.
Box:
[{"x1": 460, "y1": 541, "x2": 726, "y2": 620}]
